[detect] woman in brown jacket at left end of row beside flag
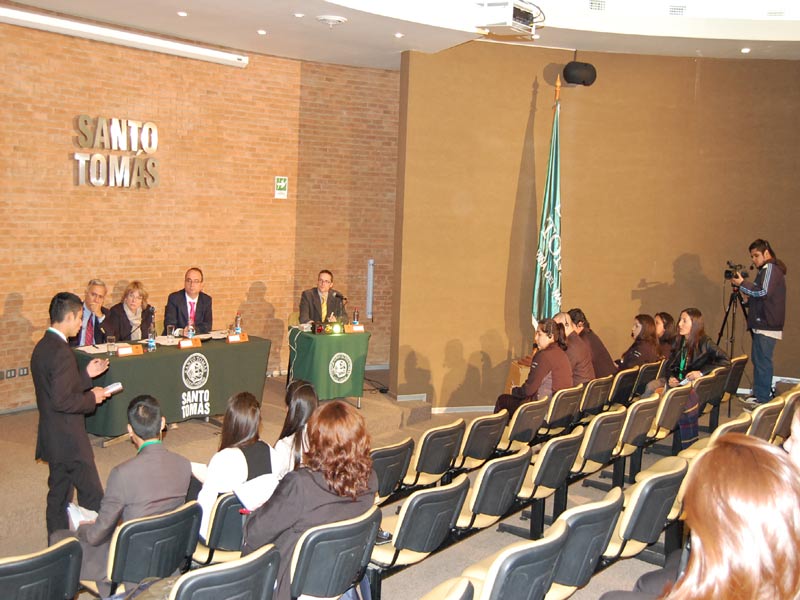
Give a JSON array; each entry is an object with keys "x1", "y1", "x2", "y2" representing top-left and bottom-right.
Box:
[{"x1": 494, "y1": 319, "x2": 572, "y2": 417}]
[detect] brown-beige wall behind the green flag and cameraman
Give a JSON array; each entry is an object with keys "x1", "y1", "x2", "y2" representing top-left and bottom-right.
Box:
[{"x1": 392, "y1": 42, "x2": 800, "y2": 407}]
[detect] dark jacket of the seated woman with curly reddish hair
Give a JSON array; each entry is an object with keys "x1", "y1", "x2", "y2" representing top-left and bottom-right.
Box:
[{"x1": 242, "y1": 469, "x2": 378, "y2": 600}]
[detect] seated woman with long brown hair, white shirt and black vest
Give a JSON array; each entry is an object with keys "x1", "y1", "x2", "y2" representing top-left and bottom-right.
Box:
[{"x1": 187, "y1": 392, "x2": 279, "y2": 539}]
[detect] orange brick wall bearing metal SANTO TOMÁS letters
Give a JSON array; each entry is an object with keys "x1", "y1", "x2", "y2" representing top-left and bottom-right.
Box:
[{"x1": 0, "y1": 25, "x2": 399, "y2": 410}]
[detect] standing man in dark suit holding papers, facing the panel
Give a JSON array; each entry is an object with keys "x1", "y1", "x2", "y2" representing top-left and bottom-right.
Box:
[{"x1": 31, "y1": 292, "x2": 109, "y2": 535}]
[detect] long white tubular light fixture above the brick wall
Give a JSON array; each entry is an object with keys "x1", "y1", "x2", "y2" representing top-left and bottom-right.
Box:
[{"x1": 0, "y1": 6, "x2": 250, "y2": 67}]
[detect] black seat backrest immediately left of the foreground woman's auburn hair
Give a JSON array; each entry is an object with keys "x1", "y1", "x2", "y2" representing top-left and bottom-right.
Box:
[{"x1": 618, "y1": 456, "x2": 689, "y2": 544}]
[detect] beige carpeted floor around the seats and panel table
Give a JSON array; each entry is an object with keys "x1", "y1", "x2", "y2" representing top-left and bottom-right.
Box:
[{"x1": 0, "y1": 371, "x2": 739, "y2": 600}]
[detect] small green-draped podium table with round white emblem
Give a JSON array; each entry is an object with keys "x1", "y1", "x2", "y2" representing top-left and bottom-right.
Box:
[{"x1": 289, "y1": 328, "x2": 370, "y2": 408}]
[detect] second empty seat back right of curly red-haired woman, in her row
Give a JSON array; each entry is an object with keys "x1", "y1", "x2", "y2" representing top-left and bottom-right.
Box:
[{"x1": 470, "y1": 448, "x2": 532, "y2": 517}]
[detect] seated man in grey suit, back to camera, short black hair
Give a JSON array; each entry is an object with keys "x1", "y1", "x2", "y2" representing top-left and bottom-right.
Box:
[{"x1": 51, "y1": 396, "x2": 192, "y2": 598}]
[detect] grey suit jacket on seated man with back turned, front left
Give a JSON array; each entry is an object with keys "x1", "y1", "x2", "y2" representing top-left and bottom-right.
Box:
[{"x1": 76, "y1": 444, "x2": 192, "y2": 581}]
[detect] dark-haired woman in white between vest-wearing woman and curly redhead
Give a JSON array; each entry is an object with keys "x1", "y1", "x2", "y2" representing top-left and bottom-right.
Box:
[{"x1": 273, "y1": 379, "x2": 319, "y2": 479}]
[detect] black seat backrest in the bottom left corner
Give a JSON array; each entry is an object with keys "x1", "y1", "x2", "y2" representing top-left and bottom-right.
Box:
[{"x1": 0, "y1": 538, "x2": 83, "y2": 600}]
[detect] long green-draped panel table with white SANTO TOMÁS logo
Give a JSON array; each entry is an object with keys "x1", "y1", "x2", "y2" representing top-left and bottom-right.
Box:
[{"x1": 75, "y1": 336, "x2": 271, "y2": 436}]
